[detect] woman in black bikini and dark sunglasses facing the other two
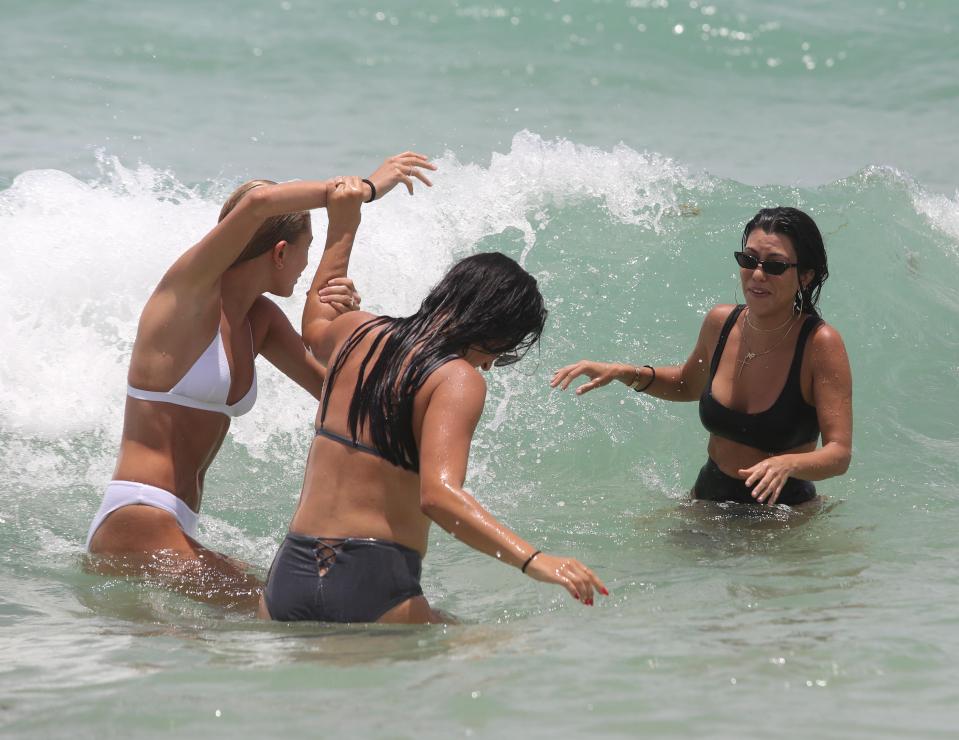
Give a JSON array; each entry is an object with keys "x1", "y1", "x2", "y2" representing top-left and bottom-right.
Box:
[{"x1": 551, "y1": 207, "x2": 852, "y2": 506}]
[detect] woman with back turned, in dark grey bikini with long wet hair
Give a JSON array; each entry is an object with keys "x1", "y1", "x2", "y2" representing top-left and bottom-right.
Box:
[{"x1": 260, "y1": 180, "x2": 606, "y2": 623}]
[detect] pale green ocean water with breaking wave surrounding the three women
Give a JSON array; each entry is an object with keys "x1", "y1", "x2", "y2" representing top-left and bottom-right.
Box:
[{"x1": 0, "y1": 0, "x2": 959, "y2": 738}]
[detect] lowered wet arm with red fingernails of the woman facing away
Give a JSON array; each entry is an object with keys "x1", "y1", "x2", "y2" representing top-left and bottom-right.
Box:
[{"x1": 420, "y1": 363, "x2": 608, "y2": 606}]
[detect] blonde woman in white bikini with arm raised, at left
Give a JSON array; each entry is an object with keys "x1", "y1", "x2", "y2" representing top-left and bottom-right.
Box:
[{"x1": 87, "y1": 152, "x2": 435, "y2": 606}]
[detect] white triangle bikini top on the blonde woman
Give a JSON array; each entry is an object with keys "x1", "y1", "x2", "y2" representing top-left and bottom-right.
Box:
[{"x1": 127, "y1": 331, "x2": 256, "y2": 417}]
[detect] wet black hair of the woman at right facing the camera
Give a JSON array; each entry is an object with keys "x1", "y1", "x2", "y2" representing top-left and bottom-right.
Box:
[{"x1": 743, "y1": 206, "x2": 829, "y2": 316}]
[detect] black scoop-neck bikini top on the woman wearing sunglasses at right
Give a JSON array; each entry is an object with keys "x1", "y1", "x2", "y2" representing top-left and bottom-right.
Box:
[{"x1": 699, "y1": 305, "x2": 822, "y2": 452}]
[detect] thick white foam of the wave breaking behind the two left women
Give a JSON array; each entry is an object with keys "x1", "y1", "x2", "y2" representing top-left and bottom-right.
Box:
[{"x1": 0, "y1": 132, "x2": 703, "y2": 455}]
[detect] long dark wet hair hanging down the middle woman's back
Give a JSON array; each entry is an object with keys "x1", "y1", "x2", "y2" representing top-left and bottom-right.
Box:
[{"x1": 320, "y1": 252, "x2": 546, "y2": 471}]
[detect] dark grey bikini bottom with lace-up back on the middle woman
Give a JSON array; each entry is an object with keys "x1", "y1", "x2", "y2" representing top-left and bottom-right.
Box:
[{"x1": 263, "y1": 532, "x2": 423, "y2": 622}]
